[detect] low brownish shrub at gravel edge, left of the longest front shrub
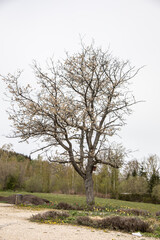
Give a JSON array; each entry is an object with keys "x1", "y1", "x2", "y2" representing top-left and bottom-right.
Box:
[{"x1": 30, "y1": 211, "x2": 69, "y2": 221}]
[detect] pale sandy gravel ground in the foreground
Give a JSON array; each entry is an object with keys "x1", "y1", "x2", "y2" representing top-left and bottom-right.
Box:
[{"x1": 0, "y1": 203, "x2": 158, "y2": 240}]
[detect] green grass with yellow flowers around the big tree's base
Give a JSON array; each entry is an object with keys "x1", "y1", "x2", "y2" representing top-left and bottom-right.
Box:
[{"x1": 0, "y1": 191, "x2": 160, "y2": 238}]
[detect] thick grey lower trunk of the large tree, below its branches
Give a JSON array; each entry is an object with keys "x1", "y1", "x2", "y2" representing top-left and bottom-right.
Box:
[{"x1": 84, "y1": 173, "x2": 95, "y2": 205}]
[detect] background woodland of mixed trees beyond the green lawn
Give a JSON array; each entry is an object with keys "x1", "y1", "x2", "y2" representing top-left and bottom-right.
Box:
[{"x1": 0, "y1": 145, "x2": 160, "y2": 203}]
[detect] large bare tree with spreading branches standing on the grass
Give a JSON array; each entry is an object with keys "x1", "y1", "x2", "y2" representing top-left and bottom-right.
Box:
[{"x1": 3, "y1": 44, "x2": 137, "y2": 204}]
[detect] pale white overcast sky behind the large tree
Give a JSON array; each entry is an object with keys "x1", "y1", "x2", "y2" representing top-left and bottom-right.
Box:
[{"x1": 0, "y1": 0, "x2": 160, "y2": 159}]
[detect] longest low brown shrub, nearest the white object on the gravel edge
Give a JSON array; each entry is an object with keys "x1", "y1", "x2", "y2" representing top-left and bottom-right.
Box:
[{"x1": 77, "y1": 216, "x2": 151, "y2": 232}]
